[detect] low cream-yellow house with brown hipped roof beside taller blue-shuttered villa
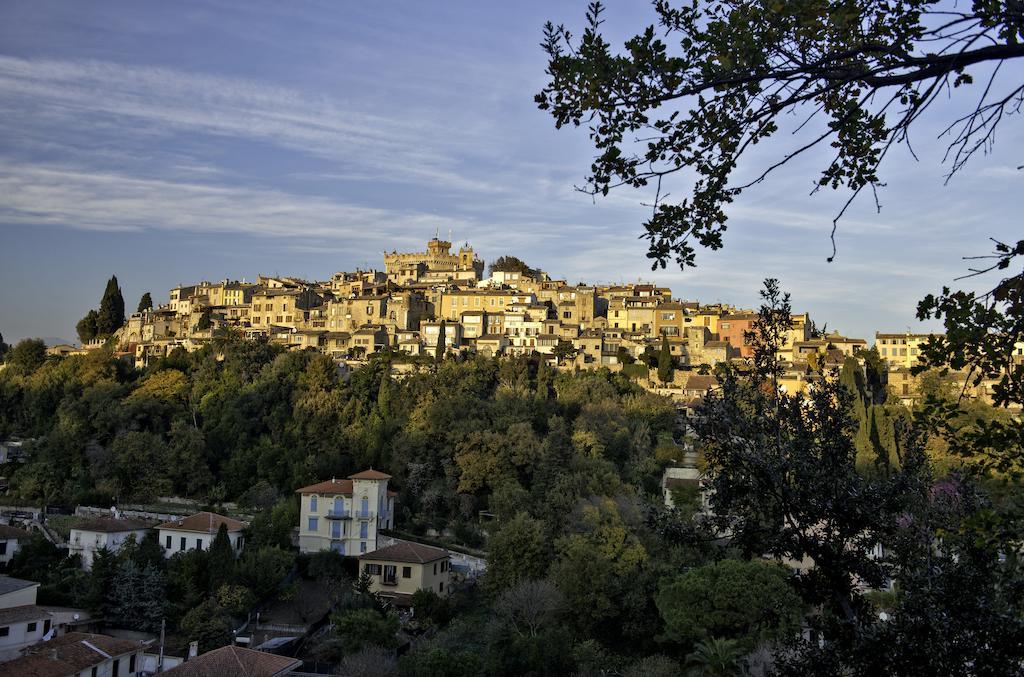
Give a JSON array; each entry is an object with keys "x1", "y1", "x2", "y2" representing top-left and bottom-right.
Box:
[{"x1": 359, "y1": 541, "x2": 452, "y2": 606}]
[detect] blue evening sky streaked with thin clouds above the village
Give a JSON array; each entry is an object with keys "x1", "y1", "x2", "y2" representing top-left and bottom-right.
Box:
[{"x1": 0, "y1": 0, "x2": 1024, "y2": 343}]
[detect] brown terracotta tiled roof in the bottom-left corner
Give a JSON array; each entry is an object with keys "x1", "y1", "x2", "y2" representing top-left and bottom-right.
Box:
[{"x1": 0, "y1": 632, "x2": 142, "y2": 677}]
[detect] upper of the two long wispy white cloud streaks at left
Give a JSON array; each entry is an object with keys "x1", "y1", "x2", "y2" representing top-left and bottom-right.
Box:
[{"x1": 0, "y1": 56, "x2": 501, "y2": 192}]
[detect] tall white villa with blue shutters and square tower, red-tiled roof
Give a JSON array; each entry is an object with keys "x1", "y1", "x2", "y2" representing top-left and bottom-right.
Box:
[{"x1": 296, "y1": 470, "x2": 397, "y2": 556}]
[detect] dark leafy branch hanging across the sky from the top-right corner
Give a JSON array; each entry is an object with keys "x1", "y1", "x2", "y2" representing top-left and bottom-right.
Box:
[{"x1": 536, "y1": 0, "x2": 1024, "y2": 268}]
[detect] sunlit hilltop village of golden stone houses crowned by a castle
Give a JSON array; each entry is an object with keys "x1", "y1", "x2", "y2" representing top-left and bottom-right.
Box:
[{"x1": 66, "y1": 238, "x2": 985, "y2": 404}]
